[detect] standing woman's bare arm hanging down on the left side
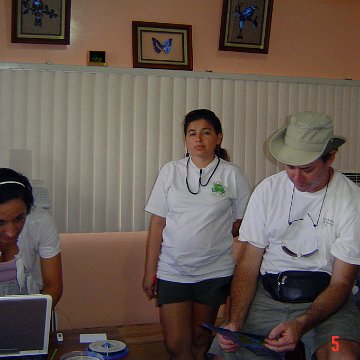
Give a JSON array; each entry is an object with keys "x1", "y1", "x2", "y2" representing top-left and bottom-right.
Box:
[{"x1": 142, "y1": 215, "x2": 166, "y2": 300}]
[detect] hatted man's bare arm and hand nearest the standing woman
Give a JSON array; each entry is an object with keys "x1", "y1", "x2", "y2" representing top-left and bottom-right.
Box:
[{"x1": 217, "y1": 242, "x2": 264, "y2": 352}]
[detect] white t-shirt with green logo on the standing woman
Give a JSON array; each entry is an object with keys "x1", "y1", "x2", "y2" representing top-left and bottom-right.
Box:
[{"x1": 145, "y1": 158, "x2": 250, "y2": 283}]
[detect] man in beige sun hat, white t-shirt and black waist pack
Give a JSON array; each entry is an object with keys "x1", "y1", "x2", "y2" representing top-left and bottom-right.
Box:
[{"x1": 209, "y1": 111, "x2": 360, "y2": 360}]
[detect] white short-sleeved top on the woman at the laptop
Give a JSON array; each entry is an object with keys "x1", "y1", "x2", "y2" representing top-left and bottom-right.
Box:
[{"x1": 15, "y1": 206, "x2": 60, "y2": 294}]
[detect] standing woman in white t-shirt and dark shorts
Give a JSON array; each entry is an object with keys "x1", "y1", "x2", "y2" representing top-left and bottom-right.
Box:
[{"x1": 143, "y1": 109, "x2": 250, "y2": 360}]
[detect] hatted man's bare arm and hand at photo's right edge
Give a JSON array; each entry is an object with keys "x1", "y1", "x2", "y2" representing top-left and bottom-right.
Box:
[{"x1": 266, "y1": 259, "x2": 359, "y2": 351}]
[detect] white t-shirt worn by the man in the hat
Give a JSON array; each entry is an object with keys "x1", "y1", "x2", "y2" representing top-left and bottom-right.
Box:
[{"x1": 239, "y1": 171, "x2": 360, "y2": 274}]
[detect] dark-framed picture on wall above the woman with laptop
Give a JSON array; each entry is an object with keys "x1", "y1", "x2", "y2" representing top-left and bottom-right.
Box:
[{"x1": 11, "y1": 0, "x2": 71, "y2": 45}]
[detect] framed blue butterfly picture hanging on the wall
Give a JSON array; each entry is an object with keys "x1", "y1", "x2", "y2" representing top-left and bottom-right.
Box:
[{"x1": 132, "y1": 21, "x2": 193, "y2": 70}]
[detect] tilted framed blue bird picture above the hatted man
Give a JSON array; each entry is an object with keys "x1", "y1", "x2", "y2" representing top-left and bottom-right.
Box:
[{"x1": 219, "y1": 0, "x2": 274, "y2": 54}]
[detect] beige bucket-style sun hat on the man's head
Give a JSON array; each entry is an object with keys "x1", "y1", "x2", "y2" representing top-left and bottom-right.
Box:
[{"x1": 269, "y1": 111, "x2": 346, "y2": 166}]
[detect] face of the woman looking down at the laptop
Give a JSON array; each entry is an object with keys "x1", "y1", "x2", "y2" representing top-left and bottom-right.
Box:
[{"x1": 0, "y1": 199, "x2": 27, "y2": 251}]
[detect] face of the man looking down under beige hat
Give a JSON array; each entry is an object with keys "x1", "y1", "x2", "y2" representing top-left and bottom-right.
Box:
[{"x1": 285, "y1": 152, "x2": 335, "y2": 192}]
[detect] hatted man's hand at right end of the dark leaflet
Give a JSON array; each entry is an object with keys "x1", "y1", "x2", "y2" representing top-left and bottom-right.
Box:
[{"x1": 265, "y1": 320, "x2": 303, "y2": 352}]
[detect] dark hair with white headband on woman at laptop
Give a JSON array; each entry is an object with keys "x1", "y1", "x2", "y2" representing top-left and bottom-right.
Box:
[{"x1": 0, "y1": 168, "x2": 34, "y2": 213}]
